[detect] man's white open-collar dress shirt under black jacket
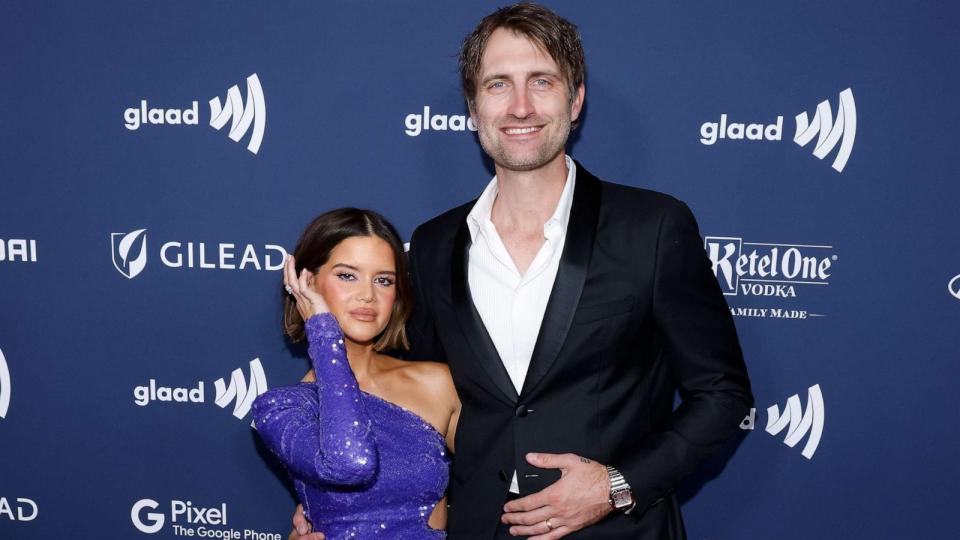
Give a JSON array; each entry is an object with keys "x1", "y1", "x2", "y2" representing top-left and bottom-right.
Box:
[{"x1": 467, "y1": 156, "x2": 577, "y2": 493}]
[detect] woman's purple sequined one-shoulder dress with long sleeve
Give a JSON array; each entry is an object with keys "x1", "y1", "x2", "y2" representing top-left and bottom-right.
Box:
[{"x1": 253, "y1": 313, "x2": 450, "y2": 540}]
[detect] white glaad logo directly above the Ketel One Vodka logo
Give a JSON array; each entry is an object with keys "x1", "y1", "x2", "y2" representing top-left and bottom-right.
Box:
[{"x1": 700, "y1": 88, "x2": 857, "y2": 172}]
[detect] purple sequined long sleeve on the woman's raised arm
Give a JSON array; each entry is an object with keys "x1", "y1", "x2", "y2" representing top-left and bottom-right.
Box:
[{"x1": 253, "y1": 313, "x2": 379, "y2": 486}]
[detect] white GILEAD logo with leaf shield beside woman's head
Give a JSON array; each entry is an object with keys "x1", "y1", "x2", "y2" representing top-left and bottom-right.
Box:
[{"x1": 110, "y1": 229, "x2": 287, "y2": 279}]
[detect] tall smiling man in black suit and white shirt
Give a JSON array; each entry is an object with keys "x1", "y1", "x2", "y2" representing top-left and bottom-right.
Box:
[{"x1": 292, "y1": 4, "x2": 752, "y2": 540}]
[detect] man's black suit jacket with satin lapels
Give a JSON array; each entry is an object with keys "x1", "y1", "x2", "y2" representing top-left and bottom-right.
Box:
[{"x1": 409, "y1": 163, "x2": 753, "y2": 539}]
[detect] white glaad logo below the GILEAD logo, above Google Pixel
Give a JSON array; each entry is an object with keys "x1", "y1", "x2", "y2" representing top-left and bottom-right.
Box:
[{"x1": 133, "y1": 358, "x2": 268, "y2": 419}]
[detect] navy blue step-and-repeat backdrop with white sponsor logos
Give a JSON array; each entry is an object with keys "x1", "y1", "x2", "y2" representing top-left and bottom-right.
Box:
[{"x1": 0, "y1": 0, "x2": 960, "y2": 540}]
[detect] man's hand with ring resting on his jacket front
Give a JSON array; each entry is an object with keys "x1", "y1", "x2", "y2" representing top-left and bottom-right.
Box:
[{"x1": 500, "y1": 453, "x2": 612, "y2": 540}]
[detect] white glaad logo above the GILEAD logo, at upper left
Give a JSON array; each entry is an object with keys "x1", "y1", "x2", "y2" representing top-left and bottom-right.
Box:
[{"x1": 123, "y1": 73, "x2": 267, "y2": 154}]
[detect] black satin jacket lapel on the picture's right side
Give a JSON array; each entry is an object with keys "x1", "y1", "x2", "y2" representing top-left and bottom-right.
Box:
[{"x1": 520, "y1": 163, "x2": 600, "y2": 396}]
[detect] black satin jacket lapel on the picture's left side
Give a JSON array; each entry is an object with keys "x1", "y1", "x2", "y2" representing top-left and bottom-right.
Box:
[{"x1": 450, "y1": 219, "x2": 518, "y2": 404}]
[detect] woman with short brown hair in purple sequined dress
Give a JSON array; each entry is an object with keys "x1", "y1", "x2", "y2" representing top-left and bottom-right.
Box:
[{"x1": 253, "y1": 208, "x2": 460, "y2": 540}]
